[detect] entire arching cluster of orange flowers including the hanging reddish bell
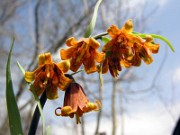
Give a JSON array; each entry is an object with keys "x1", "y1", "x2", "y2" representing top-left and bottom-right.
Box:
[{"x1": 25, "y1": 20, "x2": 159, "y2": 124}]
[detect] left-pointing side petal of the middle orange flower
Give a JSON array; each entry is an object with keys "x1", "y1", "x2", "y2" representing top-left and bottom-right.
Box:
[{"x1": 60, "y1": 47, "x2": 77, "y2": 60}]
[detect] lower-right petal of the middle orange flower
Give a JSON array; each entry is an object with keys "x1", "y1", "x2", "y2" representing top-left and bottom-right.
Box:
[{"x1": 83, "y1": 56, "x2": 97, "y2": 74}]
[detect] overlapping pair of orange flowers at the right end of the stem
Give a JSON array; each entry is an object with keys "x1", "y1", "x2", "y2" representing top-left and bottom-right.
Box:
[{"x1": 102, "y1": 20, "x2": 159, "y2": 77}]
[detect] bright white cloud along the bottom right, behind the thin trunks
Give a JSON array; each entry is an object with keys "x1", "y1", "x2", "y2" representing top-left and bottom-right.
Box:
[{"x1": 51, "y1": 104, "x2": 179, "y2": 135}]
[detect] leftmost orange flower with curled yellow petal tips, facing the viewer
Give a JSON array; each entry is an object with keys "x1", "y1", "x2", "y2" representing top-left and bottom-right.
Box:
[{"x1": 25, "y1": 53, "x2": 71, "y2": 99}]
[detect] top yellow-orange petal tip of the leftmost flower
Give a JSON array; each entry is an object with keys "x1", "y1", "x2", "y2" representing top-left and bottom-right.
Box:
[{"x1": 39, "y1": 53, "x2": 52, "y2": 66}]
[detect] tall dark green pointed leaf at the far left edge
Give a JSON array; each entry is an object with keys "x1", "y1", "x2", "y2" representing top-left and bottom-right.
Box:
[{"x1": 6, "y1": 39, "x2": 23, "y2": 135}]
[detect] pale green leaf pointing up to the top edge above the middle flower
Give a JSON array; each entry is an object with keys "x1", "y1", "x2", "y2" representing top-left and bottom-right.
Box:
[{"x1": 84, "y1": 0, "x2": 102, "y2": 38}]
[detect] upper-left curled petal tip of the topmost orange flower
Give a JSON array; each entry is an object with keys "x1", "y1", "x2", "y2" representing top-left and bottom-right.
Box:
[{"x1": 107, "y1": 25, "x2": 121, "y2": 39}]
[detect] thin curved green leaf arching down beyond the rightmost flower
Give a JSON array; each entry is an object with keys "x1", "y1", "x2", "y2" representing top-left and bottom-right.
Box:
[{"x1": 133, "y1": 32, "x2": 175, "y2": 52}]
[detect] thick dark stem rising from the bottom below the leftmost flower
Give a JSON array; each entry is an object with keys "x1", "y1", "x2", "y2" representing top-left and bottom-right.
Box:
[{"x1": 28, "y1": 91, "x2": 47, "y2": 135}]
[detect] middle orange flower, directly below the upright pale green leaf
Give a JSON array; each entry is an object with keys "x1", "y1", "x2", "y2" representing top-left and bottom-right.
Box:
[{"x1": 60, "y1": 37, "x2": 104, "y2": 74}]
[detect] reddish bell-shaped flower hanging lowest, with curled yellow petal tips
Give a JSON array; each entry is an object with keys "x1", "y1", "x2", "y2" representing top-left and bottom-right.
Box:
[{"x1": 55, "y1": 82, "x2": 101, "y2": 124}]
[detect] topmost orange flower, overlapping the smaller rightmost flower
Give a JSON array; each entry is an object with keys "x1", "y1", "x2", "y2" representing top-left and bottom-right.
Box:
[{"x1": 102, "y1": 20, "x2": 136, "y2": 77}]
